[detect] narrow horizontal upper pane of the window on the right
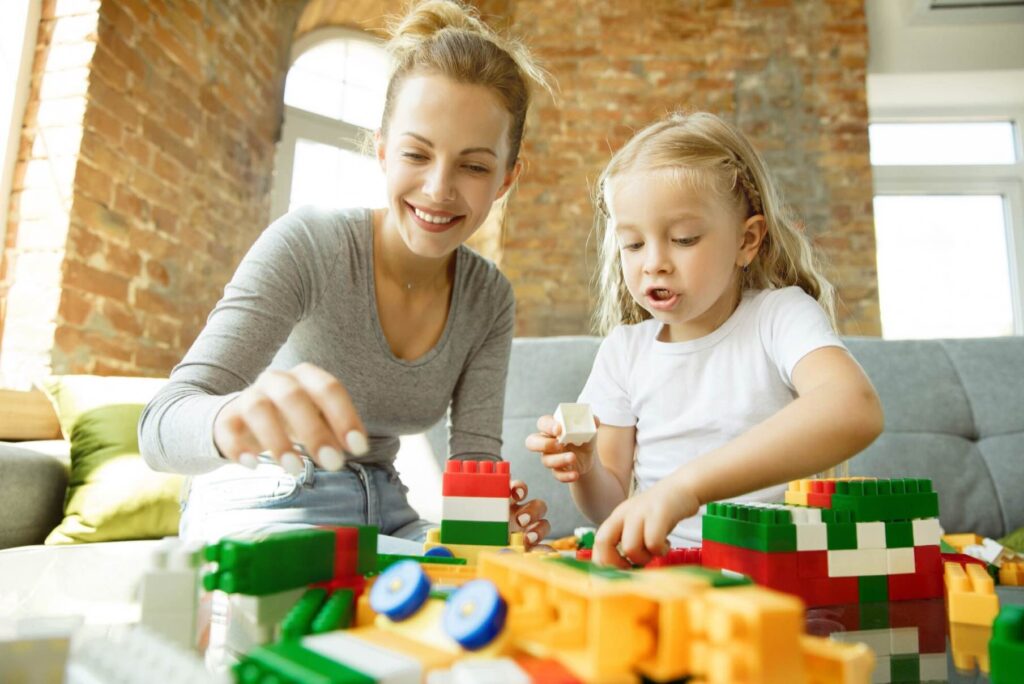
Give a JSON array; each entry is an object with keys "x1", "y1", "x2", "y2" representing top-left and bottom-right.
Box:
[{"x1": 867, "y1": 121, "x2": 1017, "y2": 166}]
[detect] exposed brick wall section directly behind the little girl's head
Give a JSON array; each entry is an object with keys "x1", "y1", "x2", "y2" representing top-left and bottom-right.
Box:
[{"x1": 502, "y1": 0, "x2": 880, "y2": 335}]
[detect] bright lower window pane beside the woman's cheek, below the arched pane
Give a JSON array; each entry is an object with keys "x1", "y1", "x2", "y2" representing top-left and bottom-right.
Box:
[{"x1": 289, "y1": 138, "x2": 385, "y2": 210}]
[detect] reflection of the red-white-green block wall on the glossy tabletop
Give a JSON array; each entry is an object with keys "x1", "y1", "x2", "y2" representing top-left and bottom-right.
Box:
[{"x1": 807, "y1": 600, "x2": 948, "y2": 684}]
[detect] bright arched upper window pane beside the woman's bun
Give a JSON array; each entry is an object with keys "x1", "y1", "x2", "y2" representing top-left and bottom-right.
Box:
[{"x1": 285, "y1": 40, "x2": 390, "y2": 129}]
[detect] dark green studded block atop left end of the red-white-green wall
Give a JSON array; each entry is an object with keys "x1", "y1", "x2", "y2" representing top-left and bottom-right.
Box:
[{"x1": 701, "y1": 503, "x2": 797, "y2": 551}]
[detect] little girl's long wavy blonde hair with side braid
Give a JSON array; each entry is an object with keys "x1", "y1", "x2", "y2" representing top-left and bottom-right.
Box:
[{"x1": 594, "y1": 112, "x2": 836, "y2": 335}]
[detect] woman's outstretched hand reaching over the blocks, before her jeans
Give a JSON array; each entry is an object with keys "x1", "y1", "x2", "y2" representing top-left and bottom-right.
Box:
[{"x1": 213, "y1": 364, "x2": 369, "y2": 474}]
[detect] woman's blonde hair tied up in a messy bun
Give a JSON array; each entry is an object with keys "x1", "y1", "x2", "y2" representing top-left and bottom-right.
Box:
[{"x1": 381, "y1": 0, "x2": 550, "y2": 169}]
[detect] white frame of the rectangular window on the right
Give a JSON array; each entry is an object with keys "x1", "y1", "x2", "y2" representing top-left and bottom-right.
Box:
[{"x1": 870, "y1": 106, "x2": 1024, "y2": 335}]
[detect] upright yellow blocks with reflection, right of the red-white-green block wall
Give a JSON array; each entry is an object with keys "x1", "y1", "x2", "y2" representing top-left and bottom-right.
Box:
[{"x1": 945, "y1": 563, "x2": 999, "y2": 673}]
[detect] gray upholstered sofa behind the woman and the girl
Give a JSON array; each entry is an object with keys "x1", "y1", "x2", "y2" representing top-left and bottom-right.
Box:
[{"x1": 0, "y1": 337, "x2": 1024, "y2": 560}]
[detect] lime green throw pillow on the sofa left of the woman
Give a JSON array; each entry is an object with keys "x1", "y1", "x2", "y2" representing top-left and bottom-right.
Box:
[{"x1": 42, "y1": 376, "x2": 183, "y2": 544}]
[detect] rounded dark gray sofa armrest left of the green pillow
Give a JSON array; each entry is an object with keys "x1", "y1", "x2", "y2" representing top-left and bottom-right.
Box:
[{"x1": 0, "y1": 442, "x2": 68, "y2": 549}]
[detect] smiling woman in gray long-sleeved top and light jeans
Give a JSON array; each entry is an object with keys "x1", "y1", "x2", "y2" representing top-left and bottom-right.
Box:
[{"x1": 139, "y1": 0, "x2": 549, "y2": 551}]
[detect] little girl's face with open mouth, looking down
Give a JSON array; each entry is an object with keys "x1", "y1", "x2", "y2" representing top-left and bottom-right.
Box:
[{"x1": 606, "y1": 169, "x2": 764, "y2": 342}]
